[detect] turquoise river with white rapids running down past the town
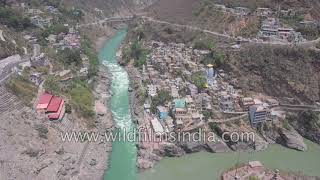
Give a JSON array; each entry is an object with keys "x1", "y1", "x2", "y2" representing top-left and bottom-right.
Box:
[{"x1": 99, "y1": 29, "x2": 137, "y2": 180}]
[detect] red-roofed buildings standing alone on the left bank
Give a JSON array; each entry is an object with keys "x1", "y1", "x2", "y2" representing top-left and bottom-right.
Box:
[{"x1": 36, "y1": 92, "x2": 65, "y2": 121}]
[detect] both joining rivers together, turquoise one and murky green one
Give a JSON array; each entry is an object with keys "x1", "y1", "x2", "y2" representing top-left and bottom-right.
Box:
[{"x1": 99, "y1": 30, "x2": 320, "y2": 180}]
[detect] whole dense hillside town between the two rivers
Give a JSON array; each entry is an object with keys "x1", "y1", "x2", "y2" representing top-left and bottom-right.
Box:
[{"x1": 139, "y1": 41, "x2": 279, "y2": 135}]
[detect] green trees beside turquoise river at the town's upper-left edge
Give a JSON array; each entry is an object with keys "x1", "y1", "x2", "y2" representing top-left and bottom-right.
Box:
[{"x1": 123, "y1": 40, "x2": 149, "y2": 68}]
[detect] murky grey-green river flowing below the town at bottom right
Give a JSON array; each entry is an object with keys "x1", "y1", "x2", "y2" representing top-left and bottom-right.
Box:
[{"x1": 139, "y1": 140, "x2": 320, "y2": 180}]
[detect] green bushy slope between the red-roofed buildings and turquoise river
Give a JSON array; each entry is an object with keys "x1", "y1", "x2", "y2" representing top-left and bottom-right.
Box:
[{"x1": 69, "y1": 80, "x2": 95, "y2": 118}]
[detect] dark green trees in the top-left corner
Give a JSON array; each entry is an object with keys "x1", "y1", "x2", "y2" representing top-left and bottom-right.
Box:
[{"x1": 0, "y1": 7, "x2": 33, "y2": 31}]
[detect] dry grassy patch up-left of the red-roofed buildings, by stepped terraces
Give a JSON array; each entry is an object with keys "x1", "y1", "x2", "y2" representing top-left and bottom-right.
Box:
[{"x1": 6, "y1": 76, "x2": 37, "y2": 105}]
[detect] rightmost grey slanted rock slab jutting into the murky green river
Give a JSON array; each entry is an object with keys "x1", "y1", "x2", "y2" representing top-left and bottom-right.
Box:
[{"x1": 279, "y1": 129, "x2": 307, "y2": 151}]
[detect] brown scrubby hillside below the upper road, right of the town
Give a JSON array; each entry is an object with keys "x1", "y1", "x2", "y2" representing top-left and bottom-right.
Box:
[{"x1": 225, "y1": 46, "x2": 320, "y2": 103}]
